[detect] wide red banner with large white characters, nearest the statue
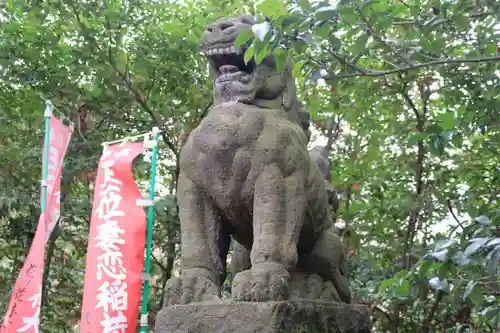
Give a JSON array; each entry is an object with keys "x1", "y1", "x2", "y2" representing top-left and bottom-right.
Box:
[{"x1": 80, "y1": 142, "x2": 146, "y2": 333}]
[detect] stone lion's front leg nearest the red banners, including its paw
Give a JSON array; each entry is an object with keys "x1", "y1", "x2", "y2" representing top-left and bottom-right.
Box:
[{"x1": 165, "y1": 172, "x2": 230, "y2": 305}]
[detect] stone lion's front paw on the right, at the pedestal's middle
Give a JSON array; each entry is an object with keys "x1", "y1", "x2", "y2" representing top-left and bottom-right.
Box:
[{"x1": 231, "y1": 263, "x2": 290, "y2": 302}]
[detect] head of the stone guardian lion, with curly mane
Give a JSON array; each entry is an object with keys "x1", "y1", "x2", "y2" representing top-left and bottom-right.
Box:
[{"x1": 201, "y1": 15, "x2": 309, "y2": 137}]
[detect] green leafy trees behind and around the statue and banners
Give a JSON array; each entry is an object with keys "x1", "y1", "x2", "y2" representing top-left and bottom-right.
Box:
[{"x1": 0, "y1": 0, "x2": 500, "y2": 333}]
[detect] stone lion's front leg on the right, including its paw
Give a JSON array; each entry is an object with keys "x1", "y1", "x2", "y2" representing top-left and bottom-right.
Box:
[{"x1": 232, "y1": 164, "x2": 306, "y2": 302}]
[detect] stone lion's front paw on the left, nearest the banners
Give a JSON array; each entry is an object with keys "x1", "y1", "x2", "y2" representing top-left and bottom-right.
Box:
[{"x1": 165, "y1": 268, "x2": 220, "y2": 305}]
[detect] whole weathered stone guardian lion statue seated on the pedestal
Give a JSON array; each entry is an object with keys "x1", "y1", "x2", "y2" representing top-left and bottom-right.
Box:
[{"x1": 161, "y1": 15, "x2": 351, "y2": 305}]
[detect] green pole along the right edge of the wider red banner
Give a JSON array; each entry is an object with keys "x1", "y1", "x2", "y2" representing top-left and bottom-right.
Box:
[{"x1": 140, "y1": 127, "x2": 160, "y2": 332}]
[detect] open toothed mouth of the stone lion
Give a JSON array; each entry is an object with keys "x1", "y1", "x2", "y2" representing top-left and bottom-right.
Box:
[{"x1": 205, "y1": 46, "x2": 256, "y2": 84}]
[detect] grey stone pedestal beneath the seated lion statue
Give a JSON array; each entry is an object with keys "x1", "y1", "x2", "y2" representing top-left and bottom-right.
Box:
[{"x1": 155, "y1": 300, "x2": 370, "y2": 333}]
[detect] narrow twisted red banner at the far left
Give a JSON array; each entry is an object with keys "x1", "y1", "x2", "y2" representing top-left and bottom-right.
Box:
[{"x1": 0, "y1": 117, "x2": 73, "y2": 333}]
